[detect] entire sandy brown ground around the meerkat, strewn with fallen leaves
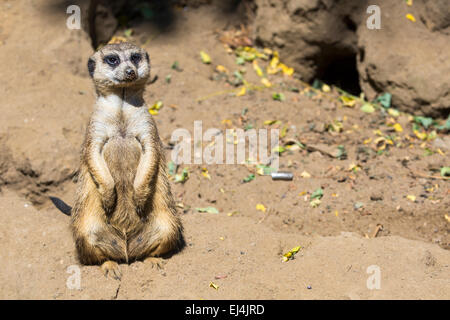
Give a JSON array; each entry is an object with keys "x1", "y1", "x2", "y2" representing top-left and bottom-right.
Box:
[{"x1": 0, "y1": 1, "x2": 450, "y2": 299}]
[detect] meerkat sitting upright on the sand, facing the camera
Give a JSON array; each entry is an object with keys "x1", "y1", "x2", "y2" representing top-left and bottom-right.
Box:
[{"x1": 71, "y1": 42, "x2": 183, "y2": 278}]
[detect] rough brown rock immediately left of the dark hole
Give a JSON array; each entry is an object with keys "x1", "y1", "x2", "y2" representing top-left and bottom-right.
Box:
[{"x1": 252, "y1": 0, "x2": 366, "y2": 81}]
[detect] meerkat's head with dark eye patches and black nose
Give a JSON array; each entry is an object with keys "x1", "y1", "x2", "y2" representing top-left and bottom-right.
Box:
[{"x1": 88, "y1": 42, "x2": 150, "y2": 90}]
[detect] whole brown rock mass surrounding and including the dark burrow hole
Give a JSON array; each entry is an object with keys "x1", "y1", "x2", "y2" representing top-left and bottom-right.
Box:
[{"x1": 248, "y1": 0, "x2": 450, "y2": 117}]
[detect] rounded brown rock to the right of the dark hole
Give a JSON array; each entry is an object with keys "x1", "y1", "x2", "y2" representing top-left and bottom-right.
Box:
[{"x1": 357, "y1": 0, "x2": 450, "y2": 117}]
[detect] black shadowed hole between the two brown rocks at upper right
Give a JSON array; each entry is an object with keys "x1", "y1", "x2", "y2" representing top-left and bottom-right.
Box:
[{"x1": 317, "y1": 55, "x2": 361, "y2": 96}]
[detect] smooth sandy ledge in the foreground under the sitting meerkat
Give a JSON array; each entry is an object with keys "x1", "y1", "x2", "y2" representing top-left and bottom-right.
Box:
[{"x1": 0, "y1": 192, "x2": 450, "y2": 300}]
